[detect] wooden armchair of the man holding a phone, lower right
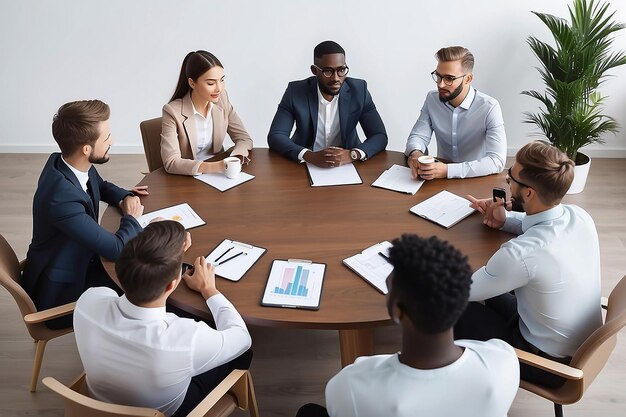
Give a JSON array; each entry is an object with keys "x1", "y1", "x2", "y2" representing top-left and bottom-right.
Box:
[{"x1": 515, "y1": 276, "x2": 626, "y2": 417}]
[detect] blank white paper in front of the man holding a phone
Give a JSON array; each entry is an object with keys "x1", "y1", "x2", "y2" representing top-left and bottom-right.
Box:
[{"x1": 409, "y1": 190, "x2": 474, "y2": 229}]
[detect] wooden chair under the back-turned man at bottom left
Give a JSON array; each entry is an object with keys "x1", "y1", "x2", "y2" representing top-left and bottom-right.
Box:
[{"x1": 42, "y1": 369, "x2": 259, "y2": 417}]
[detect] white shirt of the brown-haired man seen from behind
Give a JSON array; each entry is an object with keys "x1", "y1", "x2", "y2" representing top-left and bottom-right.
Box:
[{"x1": 74, "y1": 287, "x2": 252, "y2": 416}]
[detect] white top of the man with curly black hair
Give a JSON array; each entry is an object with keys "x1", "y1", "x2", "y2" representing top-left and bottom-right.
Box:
[{"x1": 326, "y1": 339, "x2": 519, "y2": 417}]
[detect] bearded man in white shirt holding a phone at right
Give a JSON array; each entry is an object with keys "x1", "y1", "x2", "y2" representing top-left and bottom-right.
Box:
[{"x1": 455, "y1": 142, "x2": 602, "y2": 387}]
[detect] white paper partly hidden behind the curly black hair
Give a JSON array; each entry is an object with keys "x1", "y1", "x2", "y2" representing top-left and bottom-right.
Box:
[{"x1": 343, "y1": 241, "x2": 393, "y2": 294}]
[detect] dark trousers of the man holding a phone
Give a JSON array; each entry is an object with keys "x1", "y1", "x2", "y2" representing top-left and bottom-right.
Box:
[{"x1": 454, "y1": 293, "x2": 571, "y2": 388}]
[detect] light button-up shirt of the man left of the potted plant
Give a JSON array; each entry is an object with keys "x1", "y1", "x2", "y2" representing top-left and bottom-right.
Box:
[{"x1": 405, "y1": 88, "x2": 506, "y2": 178}]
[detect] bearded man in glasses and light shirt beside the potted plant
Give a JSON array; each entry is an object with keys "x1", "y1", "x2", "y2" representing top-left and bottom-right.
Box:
[{"x1": 405, "y1": 46, "x2": 506, "y2": 180}]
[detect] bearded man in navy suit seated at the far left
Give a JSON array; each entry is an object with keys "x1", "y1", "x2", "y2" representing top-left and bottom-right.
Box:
[{"x1": 22, "y1": 100, "x2": 148, "y2": 328}]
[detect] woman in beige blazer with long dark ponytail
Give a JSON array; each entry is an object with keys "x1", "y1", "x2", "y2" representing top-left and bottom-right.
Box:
[{"x1": 161, "y1": 51, "x2": 252, "y2": 175}]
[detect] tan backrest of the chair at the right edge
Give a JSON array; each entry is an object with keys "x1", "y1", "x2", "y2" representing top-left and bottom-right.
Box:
[{"x1": 556, "y1": 276, "x2": 626, "y2": 404}]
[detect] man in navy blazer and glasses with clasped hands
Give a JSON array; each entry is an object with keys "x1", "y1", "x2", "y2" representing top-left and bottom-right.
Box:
[{"x1": 267, "y1": 41, "x2": 387, "y2": 168}]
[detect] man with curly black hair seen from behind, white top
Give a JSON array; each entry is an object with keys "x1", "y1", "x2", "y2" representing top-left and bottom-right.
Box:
[{"x1": 297, "y1": 235, "x2": 519, "y2": 417}]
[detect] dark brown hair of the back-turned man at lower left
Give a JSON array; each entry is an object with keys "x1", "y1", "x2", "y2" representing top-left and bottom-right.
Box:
[{"x1": 115, "y1": 220, "x2": 186, "y2": 305}]
